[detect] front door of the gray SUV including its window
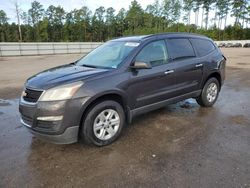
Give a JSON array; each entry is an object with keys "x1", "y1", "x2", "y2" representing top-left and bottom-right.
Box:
[{"x1": 128, "y1": 40, "x2": 176, "y2": 109}]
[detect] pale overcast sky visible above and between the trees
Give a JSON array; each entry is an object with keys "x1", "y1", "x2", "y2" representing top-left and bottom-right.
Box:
[{"x1": 0, "y1": 0, "x2": 233, "y2": 24}]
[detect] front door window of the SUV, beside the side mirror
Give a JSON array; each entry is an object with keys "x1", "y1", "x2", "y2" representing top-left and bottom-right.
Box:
[{"x1": 135, "y1": 40, "x2": 168, "y2": 66}]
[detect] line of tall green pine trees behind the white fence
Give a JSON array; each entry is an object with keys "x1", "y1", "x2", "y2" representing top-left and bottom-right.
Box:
[{"x1": 0, "y1": 0, "x2": 250, "y2": 42}]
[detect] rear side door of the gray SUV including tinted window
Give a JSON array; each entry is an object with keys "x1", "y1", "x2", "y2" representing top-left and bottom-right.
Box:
[{"x1": 167, "y1": 38, "x2": 203, "y2": 96}]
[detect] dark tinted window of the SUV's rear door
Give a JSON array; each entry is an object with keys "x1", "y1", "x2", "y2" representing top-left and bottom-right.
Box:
[{"x1": 167, "y1": 39, "x2": 195, "y2": 59}]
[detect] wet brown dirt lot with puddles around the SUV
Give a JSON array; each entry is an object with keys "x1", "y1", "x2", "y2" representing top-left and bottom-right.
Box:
[{"x1": 0, "y1": 49, "x2": 250, "y2": 188}]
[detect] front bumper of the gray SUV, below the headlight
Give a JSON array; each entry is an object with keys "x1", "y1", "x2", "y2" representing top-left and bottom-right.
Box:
[{"x1": 19, "y1": 98, "x2": 88, "y2": 144}]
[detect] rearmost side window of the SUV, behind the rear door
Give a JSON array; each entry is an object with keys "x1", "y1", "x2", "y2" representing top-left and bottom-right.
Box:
[{"x1": 191, "y1": 39, "x2": 215, "y2": 56}]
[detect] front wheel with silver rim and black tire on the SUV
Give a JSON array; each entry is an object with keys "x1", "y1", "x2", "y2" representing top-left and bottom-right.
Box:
[{"x1": 80, "y1": 100, "x2": 125, "y2": 146}]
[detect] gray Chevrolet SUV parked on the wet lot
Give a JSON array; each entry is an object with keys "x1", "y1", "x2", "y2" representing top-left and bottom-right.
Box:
[{"x1": 19, "y1": 33, "x2": 226, "y2": 146}]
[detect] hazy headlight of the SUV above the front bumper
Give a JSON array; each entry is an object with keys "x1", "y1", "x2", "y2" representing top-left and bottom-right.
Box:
[{"x1": 39, "y1": 81, "x2": 83, "y2": 101}]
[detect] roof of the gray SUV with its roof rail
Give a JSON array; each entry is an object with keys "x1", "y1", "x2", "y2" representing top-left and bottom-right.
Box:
[{"x1": 112, "y1": 32, "x2": 209, "y2": 42}]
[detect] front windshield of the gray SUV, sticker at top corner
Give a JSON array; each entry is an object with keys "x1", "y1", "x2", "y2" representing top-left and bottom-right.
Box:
[{"x1": 77, "y1": 41, "x2": 139, "y2": 68}]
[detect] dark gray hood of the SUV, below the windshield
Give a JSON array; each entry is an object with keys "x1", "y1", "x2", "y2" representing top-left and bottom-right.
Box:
[{"x1": 26, "y1": 64, "x2": 110, "y2": 89}]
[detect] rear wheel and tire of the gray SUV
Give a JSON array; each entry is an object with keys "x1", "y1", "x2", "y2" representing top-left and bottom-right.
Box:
[{"x1": 196, "y1": 77, "x2": 220, "y2": 107}]
